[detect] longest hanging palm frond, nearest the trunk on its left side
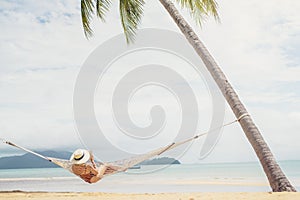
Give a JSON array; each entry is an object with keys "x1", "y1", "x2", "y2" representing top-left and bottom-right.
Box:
[{"x1": 120, "y1": 0, "x2": 145, "y2": 43}]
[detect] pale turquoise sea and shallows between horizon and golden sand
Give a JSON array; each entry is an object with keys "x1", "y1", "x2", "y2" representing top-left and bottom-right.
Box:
[{"x1": 0, "y1": 161, "x2": 300, "y2": 193}]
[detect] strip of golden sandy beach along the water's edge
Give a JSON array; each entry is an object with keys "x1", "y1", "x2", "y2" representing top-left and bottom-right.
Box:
[{"x1": 0, "y1": 192, "x2": 300, "y2": 200}]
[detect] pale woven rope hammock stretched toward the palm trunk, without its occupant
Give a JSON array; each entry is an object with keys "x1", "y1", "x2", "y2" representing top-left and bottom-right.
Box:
[{"x1": 1, "y1": 113, "x2": 249, "y2": 182}]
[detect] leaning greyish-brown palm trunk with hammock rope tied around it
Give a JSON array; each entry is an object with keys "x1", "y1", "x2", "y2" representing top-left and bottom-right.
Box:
[{"x1": 159, "y1": 0, "x2": 296, "y2": 192}]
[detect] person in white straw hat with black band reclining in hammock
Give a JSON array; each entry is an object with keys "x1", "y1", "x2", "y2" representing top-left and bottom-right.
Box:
[{"x1": 70, "y1": 149, "x2": 107, "y2": 183}]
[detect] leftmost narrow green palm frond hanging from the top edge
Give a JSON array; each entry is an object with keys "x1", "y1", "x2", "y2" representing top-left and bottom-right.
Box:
[{"x1": 81, "y1": 0, "x2": 94, "y2": 38}]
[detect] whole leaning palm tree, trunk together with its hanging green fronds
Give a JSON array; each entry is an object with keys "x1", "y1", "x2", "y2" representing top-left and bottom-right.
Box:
[{"x1": 81, "y1": 0, "x2": 296, "y2": 192}]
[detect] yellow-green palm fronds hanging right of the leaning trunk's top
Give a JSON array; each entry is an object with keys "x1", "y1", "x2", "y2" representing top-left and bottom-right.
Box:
[{"x1": 176, "y1": 0, "x2": 219, "y2": 26}]
